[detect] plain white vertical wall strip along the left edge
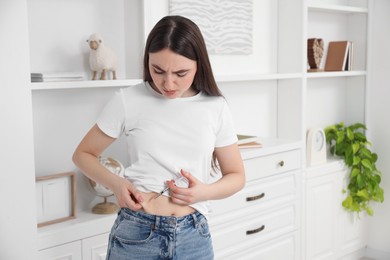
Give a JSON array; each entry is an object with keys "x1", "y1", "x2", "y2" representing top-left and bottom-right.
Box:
[{"x1": 0, "y1": 0, "x2": 37, "y2": 260}]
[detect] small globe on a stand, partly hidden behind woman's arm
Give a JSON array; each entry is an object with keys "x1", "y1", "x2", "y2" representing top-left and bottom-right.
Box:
[{"x1": 88, "y1": 156, "x2": 125, "y2": 214}]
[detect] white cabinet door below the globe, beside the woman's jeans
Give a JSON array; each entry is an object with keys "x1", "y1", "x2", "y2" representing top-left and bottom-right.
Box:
[{"x1": 82, "y1": 233, "x2": 109, "y2": 260}]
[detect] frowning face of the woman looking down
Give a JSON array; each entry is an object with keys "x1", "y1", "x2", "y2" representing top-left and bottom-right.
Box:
[{"x1": 149, "y1": 49, "x2": 197, "y2": 99}]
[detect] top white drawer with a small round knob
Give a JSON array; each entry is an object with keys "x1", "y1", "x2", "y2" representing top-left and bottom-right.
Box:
[{"x1": 244, "y1": 150, "x2": 301, "y2": 181}]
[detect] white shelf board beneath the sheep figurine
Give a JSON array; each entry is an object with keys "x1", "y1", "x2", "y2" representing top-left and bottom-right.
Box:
[{"x1": 30, "y1": 79, "x2": 142, "y2": 90}]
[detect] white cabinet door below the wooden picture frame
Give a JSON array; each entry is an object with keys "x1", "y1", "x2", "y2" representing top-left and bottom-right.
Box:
[{"x1": 38, "y1": 241, "x2": 82, "y2": 260}]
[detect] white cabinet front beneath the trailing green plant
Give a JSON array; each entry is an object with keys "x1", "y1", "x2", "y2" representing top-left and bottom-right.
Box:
[{"x1": 304, "y1": 161, "x2": 367, "y2": 260}]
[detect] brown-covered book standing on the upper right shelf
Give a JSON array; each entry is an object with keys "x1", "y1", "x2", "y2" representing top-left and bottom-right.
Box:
[{"x1": 325, "y1": 41, "x2": 352, "y2": 71}]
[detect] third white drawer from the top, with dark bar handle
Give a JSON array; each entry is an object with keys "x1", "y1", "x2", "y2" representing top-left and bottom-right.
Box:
[{"x1": 210, "y1": 204, "x2": 298, "y2": 251}]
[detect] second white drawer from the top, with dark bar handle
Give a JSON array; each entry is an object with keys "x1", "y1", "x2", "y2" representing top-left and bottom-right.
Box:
[{"x1": 211, "y1": 172, "x2": 297, "y2": 215}]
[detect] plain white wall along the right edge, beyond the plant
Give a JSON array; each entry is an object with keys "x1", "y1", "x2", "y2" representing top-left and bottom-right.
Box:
[{"x1": 368, "y1": 0, "x2": 390, "y2": 259}]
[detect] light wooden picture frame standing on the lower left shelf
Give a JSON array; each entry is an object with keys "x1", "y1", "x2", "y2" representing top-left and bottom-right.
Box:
[{"x1": 35, "y1": 172, "x2": 76, "y2": 227}]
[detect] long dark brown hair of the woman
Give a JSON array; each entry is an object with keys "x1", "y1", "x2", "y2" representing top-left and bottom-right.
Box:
[{"x1": 144, "y1": 15, "x2": 222, "y2": 96}]
